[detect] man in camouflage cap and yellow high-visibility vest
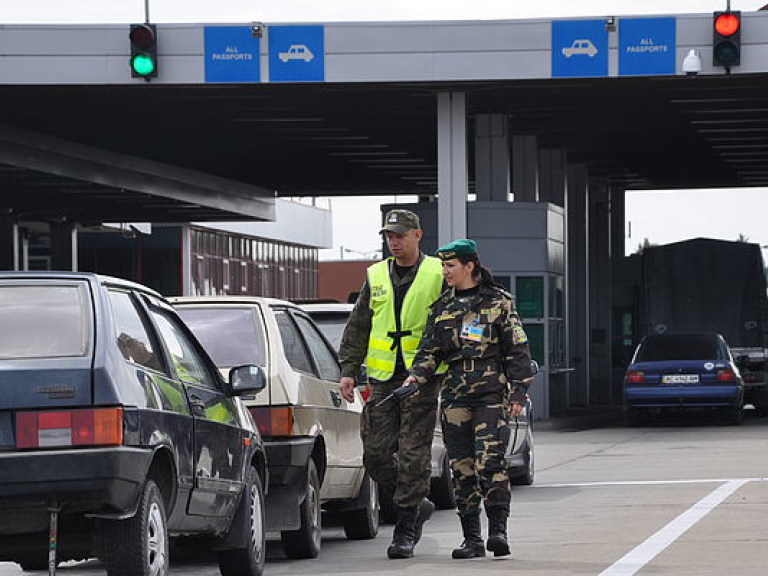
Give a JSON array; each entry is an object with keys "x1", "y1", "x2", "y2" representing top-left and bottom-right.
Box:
[{"x1": 339, "y1": 210, "x2": 443, "y2": 558}]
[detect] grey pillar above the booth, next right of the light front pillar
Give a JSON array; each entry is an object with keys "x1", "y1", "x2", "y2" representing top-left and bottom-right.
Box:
[{"x1": 475, "y1": 114, "x2": 510, "y2": 202}]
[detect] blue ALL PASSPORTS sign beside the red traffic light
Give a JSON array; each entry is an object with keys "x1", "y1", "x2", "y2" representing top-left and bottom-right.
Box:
[{"x1": 619, "y1": 18, "x2": 676, "y2": 76}]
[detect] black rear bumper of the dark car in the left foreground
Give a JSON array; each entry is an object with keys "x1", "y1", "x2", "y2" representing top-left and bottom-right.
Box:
[{"x1": 0, "y1": 446, "x2": 152, "y2": 520}]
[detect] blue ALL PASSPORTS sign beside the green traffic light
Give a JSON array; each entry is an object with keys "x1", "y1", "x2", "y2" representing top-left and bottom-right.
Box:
[{"x1": 205, "y1": 26, "x2": 260, "y2": 83}]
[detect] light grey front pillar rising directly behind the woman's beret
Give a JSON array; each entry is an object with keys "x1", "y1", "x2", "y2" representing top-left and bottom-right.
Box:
[{"x1": 437, "y1": 92, "x2": 469, "y2": 246}]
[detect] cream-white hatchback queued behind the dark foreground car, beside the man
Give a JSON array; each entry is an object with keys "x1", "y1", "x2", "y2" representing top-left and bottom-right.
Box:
[{"x1": 170, "y1": 296, "x2": 379, "y2": 558}]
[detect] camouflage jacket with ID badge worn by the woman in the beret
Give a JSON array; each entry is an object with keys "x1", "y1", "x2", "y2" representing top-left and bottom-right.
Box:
[{"x1": 411, "y1": 284, "x2": 532, "y2": 401}]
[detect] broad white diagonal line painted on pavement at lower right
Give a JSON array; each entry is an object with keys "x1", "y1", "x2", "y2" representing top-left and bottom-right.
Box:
[{"x1": 599, "y1": 479, "x2": 750, "y2": 576}]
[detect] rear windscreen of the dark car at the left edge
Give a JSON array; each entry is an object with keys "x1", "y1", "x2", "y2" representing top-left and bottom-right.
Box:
[{"x1": 0, "y1": 284, "x2": 93, "y2": 360}]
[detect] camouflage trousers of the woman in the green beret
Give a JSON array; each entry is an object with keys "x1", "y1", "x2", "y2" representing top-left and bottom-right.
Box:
[{"x1": 440, "y1": 391, "x2": 512, "y2": 516}]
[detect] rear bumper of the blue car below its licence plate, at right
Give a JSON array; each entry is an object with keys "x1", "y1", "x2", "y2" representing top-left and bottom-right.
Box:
[{"x1": 624, "y1": 385, "x2": 744, "y2": 408}]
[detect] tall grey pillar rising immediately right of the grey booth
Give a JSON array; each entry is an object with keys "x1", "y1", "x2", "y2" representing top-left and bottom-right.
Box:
[{"x1": 565, "y1": 164, "x2": 590, "y2": 406}]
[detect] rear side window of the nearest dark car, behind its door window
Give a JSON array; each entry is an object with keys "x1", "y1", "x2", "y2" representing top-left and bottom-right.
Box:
[{"x1": 109, "y1": 290, "x2": 163, "y2": 372}]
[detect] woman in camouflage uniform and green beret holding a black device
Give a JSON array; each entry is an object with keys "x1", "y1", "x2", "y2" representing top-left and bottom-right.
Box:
[{"x1": 404, "y1": 239, "x2": 533, "y2": 558}]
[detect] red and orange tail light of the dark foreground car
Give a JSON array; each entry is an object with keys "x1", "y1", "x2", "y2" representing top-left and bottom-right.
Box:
[{"x1": 16, "y1": 407, "x2": 123, "y2": 449}]
